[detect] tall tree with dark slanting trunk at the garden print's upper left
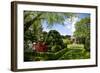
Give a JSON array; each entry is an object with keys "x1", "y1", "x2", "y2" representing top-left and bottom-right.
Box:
[{"x1": 24, "y1": 11, "x2": 42, "y2": 42}]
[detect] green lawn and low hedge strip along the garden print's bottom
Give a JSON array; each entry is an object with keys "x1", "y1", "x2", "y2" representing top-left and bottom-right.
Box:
[{"x1": 24, "y1": 44, "x2": 90, "y2": 61}]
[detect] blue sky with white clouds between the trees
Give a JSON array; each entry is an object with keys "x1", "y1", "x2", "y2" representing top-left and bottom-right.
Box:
[{"x1": 42, "y1": 13, "x2": 90, "y2": 36}]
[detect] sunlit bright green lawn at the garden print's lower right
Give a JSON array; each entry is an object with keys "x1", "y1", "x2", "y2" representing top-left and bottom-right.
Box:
[{"x1": 59, "y1": 45, "x2": 90, "y2": 60}]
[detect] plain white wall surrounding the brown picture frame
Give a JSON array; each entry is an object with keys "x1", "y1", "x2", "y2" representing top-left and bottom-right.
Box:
[{"x1": 0, "y1": 0, "x2": 100, "y2": 73}]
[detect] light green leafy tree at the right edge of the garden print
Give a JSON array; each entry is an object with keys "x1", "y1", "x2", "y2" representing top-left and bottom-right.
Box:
[{"x1": 74, "y1": 17, "x2": 90, "y2": 50}]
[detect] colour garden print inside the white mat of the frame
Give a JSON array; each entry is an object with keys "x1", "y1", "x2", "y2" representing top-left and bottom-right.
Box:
[{"x1": 24, "y1": 11, "x2": 90, "y2": 62}]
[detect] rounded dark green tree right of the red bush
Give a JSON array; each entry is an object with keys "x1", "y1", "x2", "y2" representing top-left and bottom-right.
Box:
[{"x1": 46, "y1": 30, "x2": 64, "y2": 52}]
